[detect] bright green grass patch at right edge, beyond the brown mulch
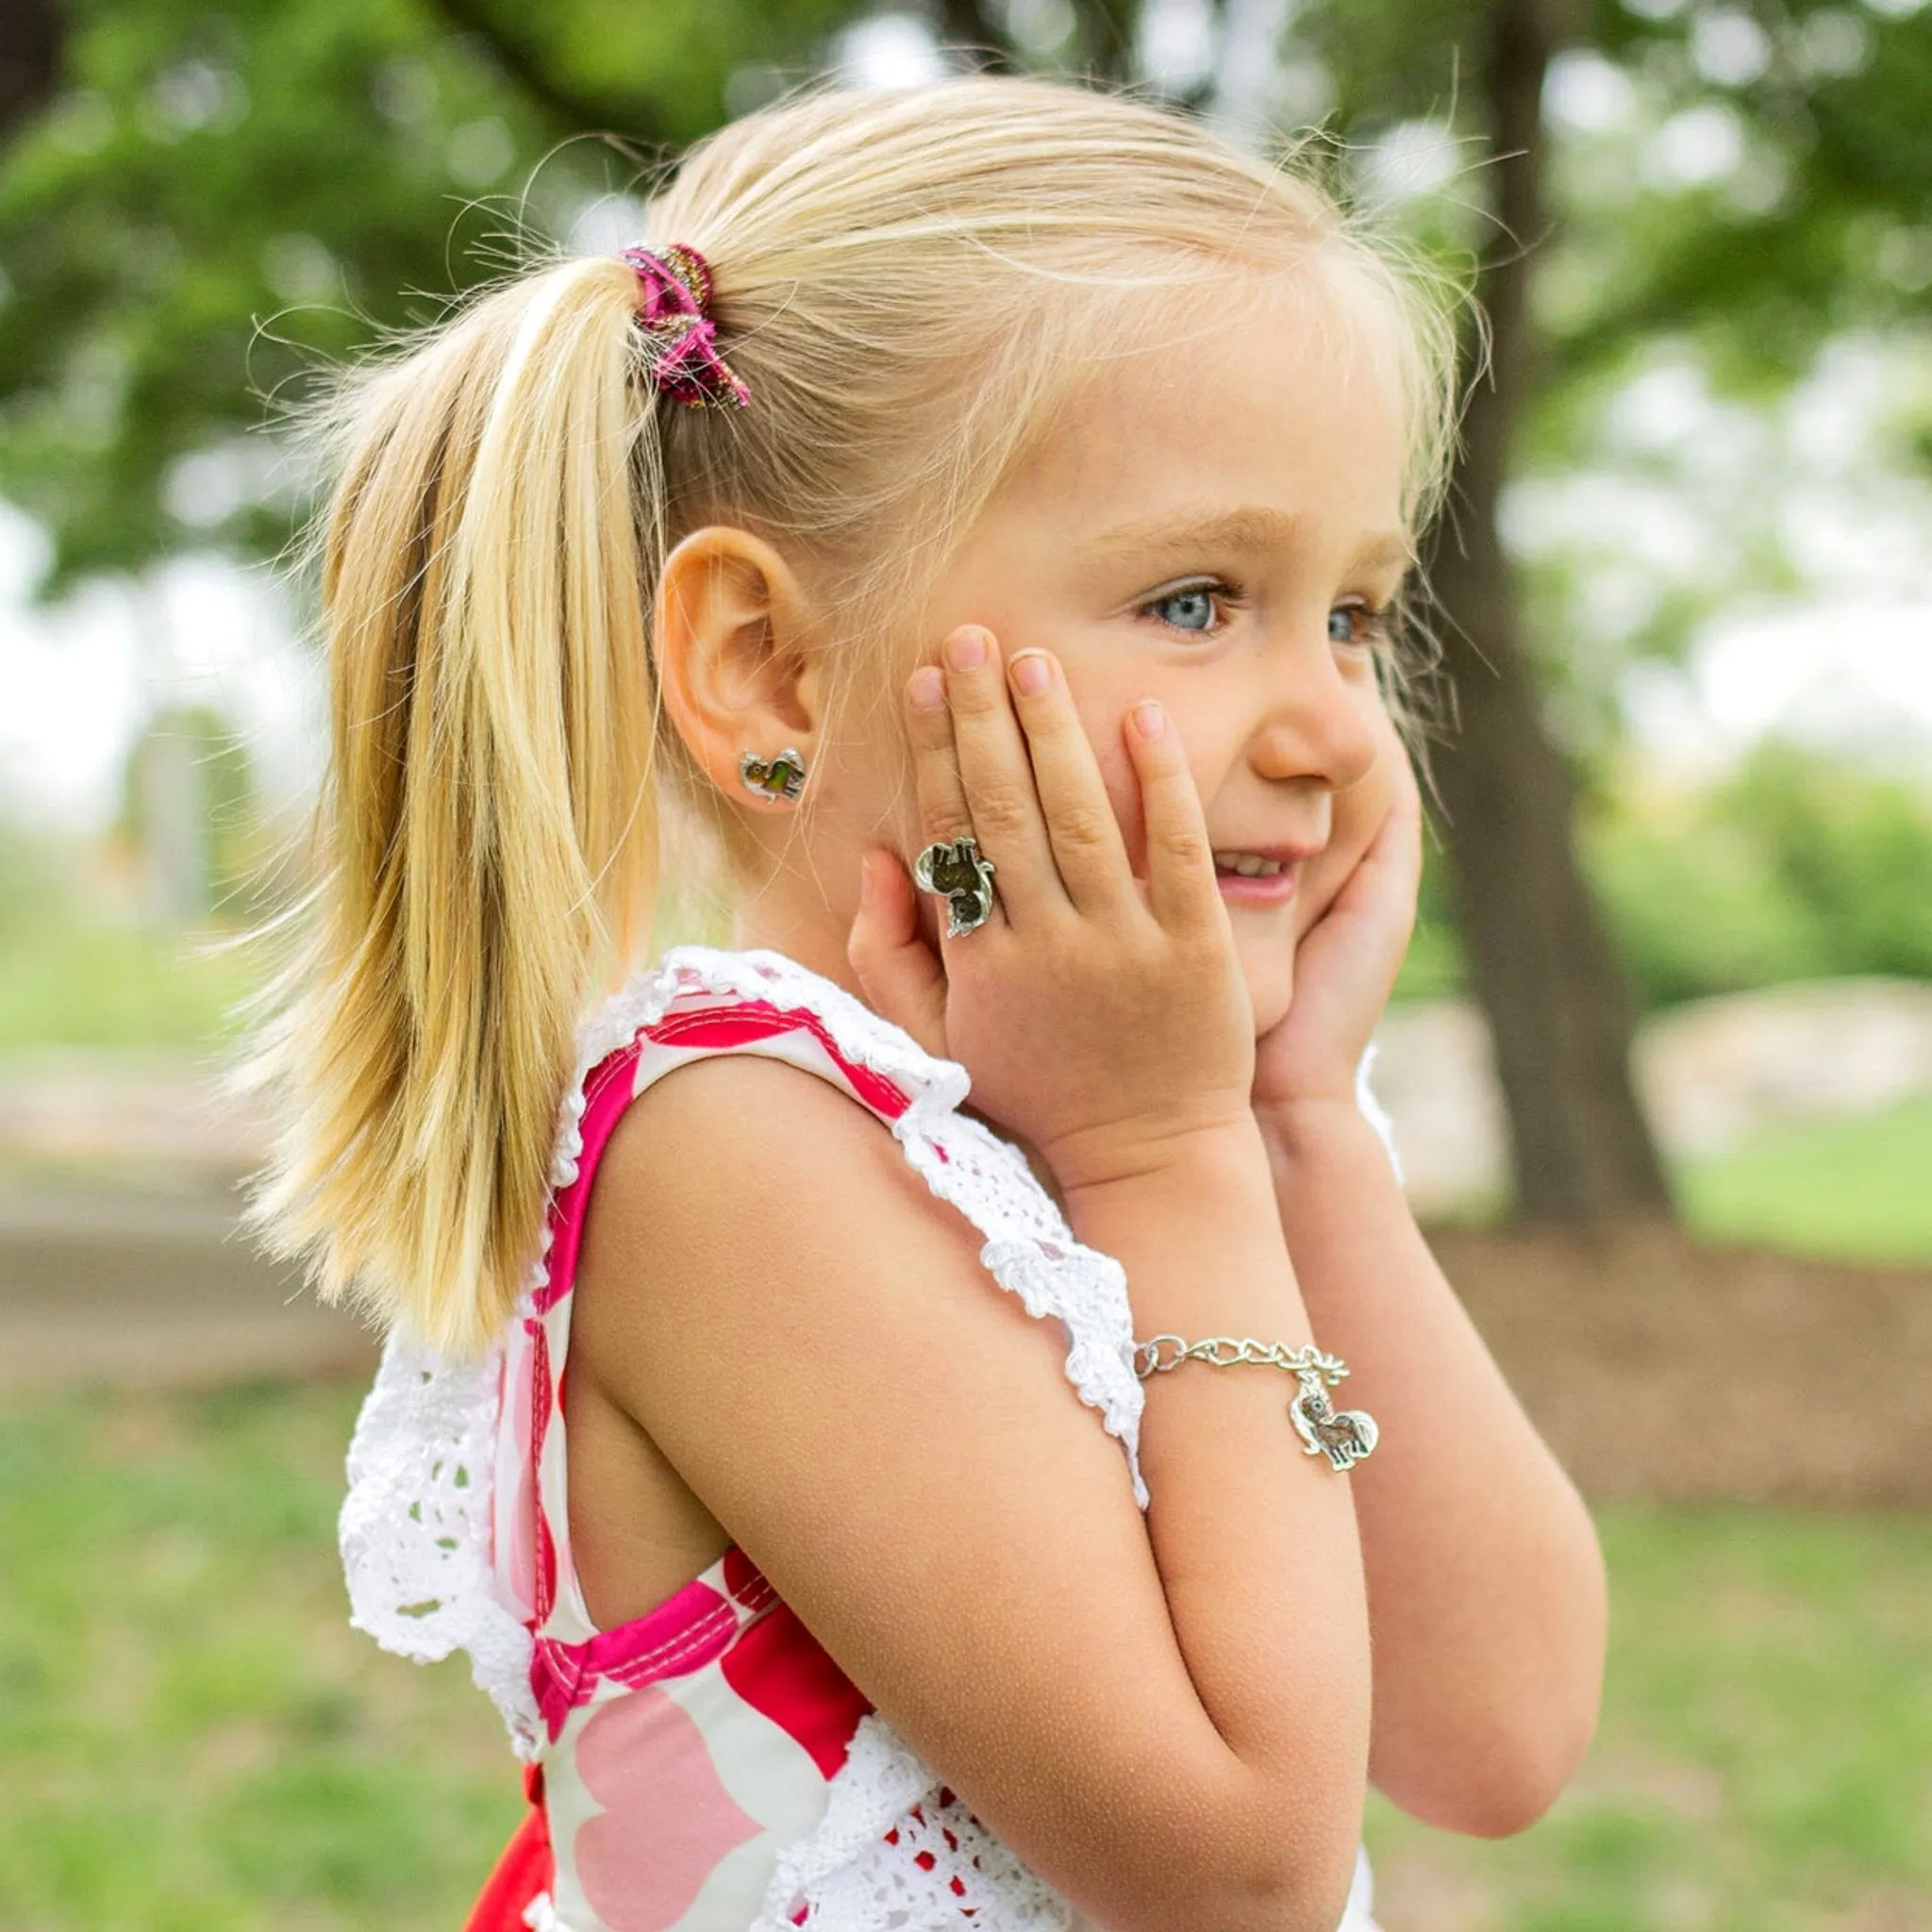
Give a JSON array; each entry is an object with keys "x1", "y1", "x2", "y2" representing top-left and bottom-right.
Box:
[{"x1": 1679, "y1": 1095, "x2": 1932, "y2": 1263}]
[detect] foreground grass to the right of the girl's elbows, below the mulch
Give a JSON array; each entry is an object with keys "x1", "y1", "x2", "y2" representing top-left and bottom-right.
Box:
[{"x1": 1370, "y1": 1508, "x2": 1932, "y2": 1932}]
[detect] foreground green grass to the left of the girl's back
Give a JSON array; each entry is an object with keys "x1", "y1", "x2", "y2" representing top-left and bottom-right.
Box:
[{"x1": 0, "y1": 1387, "x2": 522, "y2": 1932}]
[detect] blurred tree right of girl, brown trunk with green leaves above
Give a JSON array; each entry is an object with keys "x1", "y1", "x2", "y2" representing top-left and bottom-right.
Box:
[{"x1": 1289, "y1": 0, "x2": 1932, "y2": 1221}]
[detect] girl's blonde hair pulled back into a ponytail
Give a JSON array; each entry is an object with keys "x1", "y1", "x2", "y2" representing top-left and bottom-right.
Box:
[{"x1": 243, "y1": 77, "x2": 1455, "y2": 1353}]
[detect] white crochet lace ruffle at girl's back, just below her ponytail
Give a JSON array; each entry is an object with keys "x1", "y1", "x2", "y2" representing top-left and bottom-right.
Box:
[{"x1": 336, "y1": 1331, "x2": 539, "y2": 1758}]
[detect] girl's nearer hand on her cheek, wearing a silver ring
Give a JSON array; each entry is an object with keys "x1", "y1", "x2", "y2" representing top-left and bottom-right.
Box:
[{"x1": 848, "y1": 626, "x2": 1254, "y2": 1192}]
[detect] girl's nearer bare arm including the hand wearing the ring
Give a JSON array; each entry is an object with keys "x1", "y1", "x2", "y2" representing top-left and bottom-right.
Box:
[{"x1": 572, "y1": 637, "x2": 1368, "y2": 1932}]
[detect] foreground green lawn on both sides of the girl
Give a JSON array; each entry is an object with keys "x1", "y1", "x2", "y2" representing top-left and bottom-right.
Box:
[{"x1": 0, "y1": 1385, "x2": 1932, "y2": 1932}]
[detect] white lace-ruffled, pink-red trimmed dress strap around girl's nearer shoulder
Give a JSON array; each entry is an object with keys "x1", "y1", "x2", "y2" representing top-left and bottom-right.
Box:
[{"x1": 338, "y1": 947, "x2": 1148, "y2": 1757}]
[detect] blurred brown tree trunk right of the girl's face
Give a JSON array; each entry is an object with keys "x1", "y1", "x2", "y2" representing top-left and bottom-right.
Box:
[{"x1": 1427, "y1": 0, "x2": 1669, "y2": 1224}]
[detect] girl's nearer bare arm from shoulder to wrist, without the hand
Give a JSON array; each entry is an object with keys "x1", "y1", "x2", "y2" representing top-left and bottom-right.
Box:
[{"x1": 570, "y1": 1058, "x2": 1368, "y2": 1932}]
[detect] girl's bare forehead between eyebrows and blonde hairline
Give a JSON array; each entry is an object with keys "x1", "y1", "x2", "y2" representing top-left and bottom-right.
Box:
[{"x1": 995, "y1": 275, "x2": 1407, "y2": 553}]
